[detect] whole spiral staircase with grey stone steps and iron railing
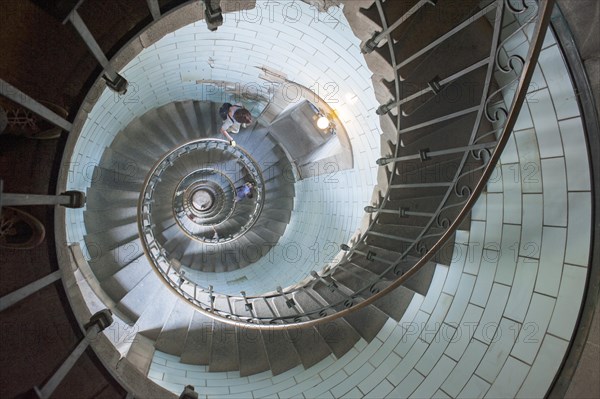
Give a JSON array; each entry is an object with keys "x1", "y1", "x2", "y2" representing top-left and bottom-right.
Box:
[{"x1": 0, "y1": 0, "x2": 596, "y2": 396}]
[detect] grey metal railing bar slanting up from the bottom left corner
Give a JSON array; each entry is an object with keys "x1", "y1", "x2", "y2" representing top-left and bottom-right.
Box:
[{"x1": 34, "y1": 309, "x2": 113, "y2": 399}]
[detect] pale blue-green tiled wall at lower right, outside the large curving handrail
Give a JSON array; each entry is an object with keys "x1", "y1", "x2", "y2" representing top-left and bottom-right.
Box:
[{"x1": 149, "y1": 7, "x2": 592, "y2": 398}]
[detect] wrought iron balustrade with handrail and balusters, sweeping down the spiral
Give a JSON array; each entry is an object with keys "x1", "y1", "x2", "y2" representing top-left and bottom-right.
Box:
[{"x1": 113, "y1": 0, "x2": 554, "y2": 329}]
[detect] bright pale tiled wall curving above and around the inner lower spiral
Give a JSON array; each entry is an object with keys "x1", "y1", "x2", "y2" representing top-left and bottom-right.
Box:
[{"x1": 67, "y1": 2, "x2": 380, "y2": 295}]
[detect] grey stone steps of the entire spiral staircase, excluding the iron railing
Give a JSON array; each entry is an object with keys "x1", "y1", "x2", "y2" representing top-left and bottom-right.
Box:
[{"x1": 76, "y1": 1, "x2": 502, "y2": 382}]
